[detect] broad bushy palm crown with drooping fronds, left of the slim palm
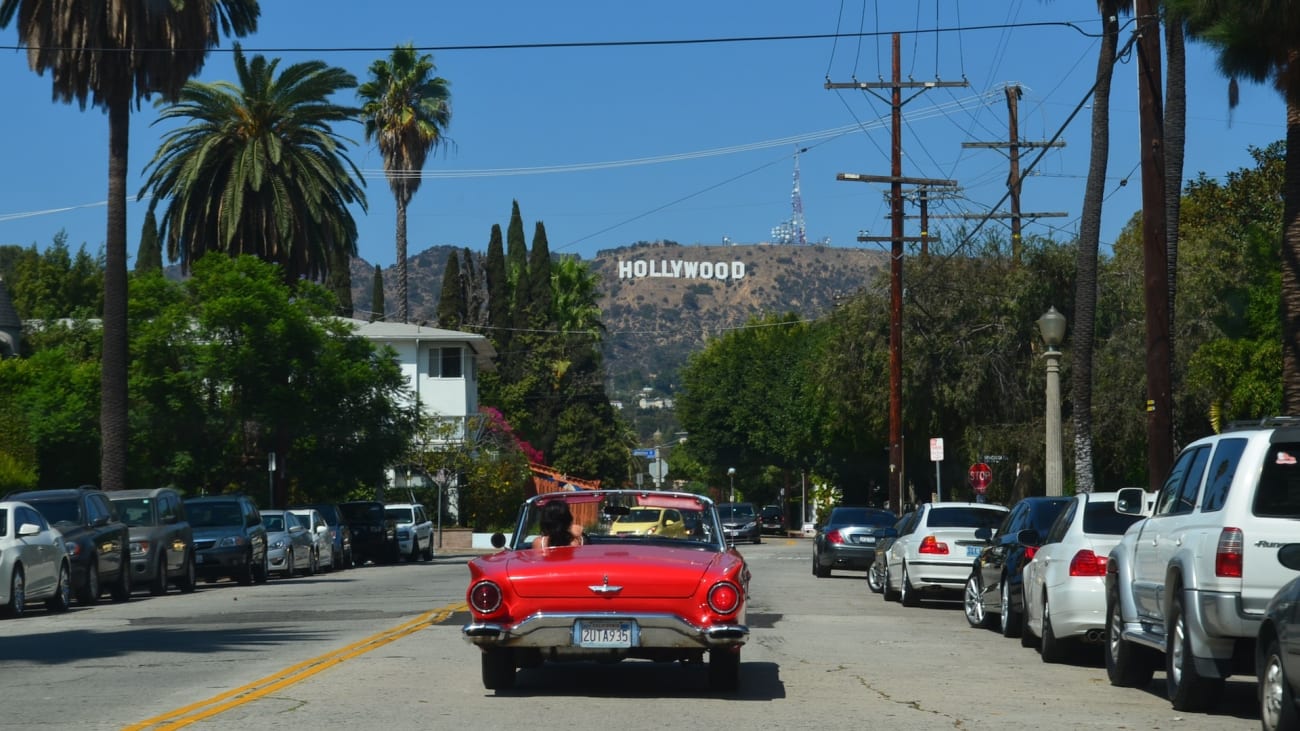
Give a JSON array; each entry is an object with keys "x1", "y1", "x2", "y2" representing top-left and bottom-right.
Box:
[{"x1": 140, "y1": 44, "x2": 365, "y2": 284}]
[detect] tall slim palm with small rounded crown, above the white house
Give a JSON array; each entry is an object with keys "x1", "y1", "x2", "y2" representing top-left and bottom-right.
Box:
[{"x1": 358, "y1": 44, "x2": 451, "y2": 323}]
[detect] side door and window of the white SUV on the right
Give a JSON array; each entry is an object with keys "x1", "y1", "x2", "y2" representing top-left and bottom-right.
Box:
[{"x1": 1132, "y1": 445, "x2": 1210, "y2": 620}]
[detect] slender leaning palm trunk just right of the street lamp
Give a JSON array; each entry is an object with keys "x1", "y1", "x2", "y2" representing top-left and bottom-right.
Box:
[{"x1": 1070, "y1": 8, "x2": 1119, "y2": 493}]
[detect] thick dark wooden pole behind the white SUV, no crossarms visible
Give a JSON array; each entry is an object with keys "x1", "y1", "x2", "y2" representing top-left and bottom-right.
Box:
[{"x1": 1135, "y1": 0, "x2": 1174, "y2": 492}]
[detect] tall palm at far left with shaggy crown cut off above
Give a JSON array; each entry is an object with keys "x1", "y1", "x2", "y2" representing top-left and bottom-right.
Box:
[{"x1": 0, "y1": 0, "x2": 260, "y2": 490}]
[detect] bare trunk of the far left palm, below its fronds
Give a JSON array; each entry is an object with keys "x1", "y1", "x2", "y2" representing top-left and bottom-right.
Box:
[{"x1": 99, "y1": 90, "x2": 131, "y2": 490}]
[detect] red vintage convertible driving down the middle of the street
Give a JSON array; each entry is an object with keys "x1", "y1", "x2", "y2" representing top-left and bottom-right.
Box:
[{"x1": 463, "y1": 490, "x2": 749, "y2": 692}]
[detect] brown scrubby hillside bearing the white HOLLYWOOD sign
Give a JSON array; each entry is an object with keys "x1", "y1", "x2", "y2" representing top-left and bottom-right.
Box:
[{"x1": 352, "y1": 243, "x2": 888, "y2": 392}]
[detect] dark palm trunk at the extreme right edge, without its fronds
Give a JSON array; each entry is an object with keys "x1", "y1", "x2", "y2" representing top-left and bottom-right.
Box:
[{"x1": 1282, "y1": 55, "x2": 1300, "y2": 415}]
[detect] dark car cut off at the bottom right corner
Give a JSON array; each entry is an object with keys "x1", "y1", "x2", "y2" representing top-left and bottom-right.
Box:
[{"x1": 1255, "y1": 544, "x2": 1300, "y2": 731}]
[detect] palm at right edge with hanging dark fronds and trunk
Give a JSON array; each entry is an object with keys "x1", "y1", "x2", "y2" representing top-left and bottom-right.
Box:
[{"x1": 1165, "y1": 0, "x2": 1300, "y2": 414}]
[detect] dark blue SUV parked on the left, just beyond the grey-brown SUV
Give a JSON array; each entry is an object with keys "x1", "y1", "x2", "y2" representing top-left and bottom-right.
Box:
[{"x1": 185, "y1": 494, "x2": 270, "y2": 585}]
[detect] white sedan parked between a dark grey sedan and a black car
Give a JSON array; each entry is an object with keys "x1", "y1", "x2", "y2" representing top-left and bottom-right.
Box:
[{"x1": 883, "y1": 502, "x2": 1008, "y2": 606}]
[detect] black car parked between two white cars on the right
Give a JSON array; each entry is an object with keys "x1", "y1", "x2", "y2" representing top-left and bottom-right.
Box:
[{"x1": 963, "y1": 496, "x2": 1070, "y2": 639}]
